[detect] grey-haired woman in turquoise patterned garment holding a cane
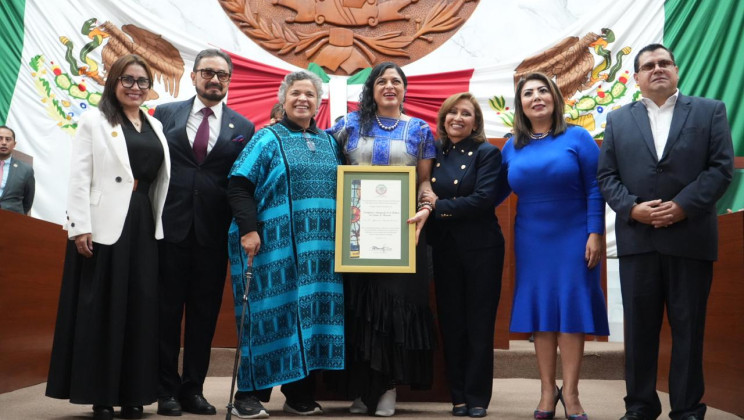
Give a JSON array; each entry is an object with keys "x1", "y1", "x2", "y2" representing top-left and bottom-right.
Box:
[{"x1": 228, "y1": 71, "x2": 344, "y2": 418}]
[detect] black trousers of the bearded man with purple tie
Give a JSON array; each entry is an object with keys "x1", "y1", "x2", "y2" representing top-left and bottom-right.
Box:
[{"x1": 158, "y1": 230, "x2": 227, "y2": 397}]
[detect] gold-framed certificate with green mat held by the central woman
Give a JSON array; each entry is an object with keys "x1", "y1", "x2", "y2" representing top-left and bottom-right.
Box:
[{"x1": 335, "y1": 165, "x2": 416, "y2": 273}]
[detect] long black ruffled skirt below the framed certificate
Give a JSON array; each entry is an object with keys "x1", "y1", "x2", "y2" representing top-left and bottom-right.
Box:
[{"x1": 328, "y1": 232, "x2": 436, "y2": 412}]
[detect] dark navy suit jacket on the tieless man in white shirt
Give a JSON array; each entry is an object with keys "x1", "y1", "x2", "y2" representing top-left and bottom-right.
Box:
[{"x1": 597, "y1": 94, "x2": 734, "y2": 261}]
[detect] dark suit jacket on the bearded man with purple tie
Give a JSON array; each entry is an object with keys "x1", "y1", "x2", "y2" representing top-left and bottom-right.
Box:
[{"x1": 155, "y1": 97, "x2": 255, "y2": 247}]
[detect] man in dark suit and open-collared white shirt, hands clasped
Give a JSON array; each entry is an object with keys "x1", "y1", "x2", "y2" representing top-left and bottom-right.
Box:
[{"x1": 597, "y1": 44, "x2": 734, "y2": 420}]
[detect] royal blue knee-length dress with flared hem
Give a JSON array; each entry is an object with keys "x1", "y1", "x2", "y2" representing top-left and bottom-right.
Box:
[{"x1": 500, "y1": 126, "x2": 609, "y2": 335}]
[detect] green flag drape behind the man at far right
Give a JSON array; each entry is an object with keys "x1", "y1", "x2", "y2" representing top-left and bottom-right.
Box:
[{"x1": 664, "y1": 0, "x2": 744, "y2": 214}]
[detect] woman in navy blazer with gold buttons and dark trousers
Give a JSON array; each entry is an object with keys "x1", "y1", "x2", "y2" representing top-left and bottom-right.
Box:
[{"x1": 419, "y1": 92, "x2": 504, "y2": 417}]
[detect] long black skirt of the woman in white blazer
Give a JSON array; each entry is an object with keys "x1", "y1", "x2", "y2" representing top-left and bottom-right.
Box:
[{"x1": 46, "y1": 191, "x2": 158, "y2": 406}]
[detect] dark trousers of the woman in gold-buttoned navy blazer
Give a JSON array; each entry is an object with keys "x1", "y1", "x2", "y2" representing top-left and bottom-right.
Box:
[{"x1": 432, "y1": 241, "x2": 504, "y2": 408}]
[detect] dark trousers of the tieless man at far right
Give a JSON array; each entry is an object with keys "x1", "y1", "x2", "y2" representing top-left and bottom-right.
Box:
[{"x1": 620, "y1": 252, "x2": 713, "y2": 420}]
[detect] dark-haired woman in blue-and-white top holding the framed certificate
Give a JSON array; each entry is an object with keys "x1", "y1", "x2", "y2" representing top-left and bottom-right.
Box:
[{"x1": 329, "y1": 62, "x2": 436, "y2": 416}]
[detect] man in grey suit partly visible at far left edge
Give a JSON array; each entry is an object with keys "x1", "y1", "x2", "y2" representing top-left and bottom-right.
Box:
[{"x1": 0, "y1": 125, "x2": 36, "y2": 214}]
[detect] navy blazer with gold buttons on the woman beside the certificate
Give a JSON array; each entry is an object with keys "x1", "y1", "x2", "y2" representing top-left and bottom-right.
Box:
[{"x1": 426, "y1": 138, "x2": 504, "y2": 249}]
